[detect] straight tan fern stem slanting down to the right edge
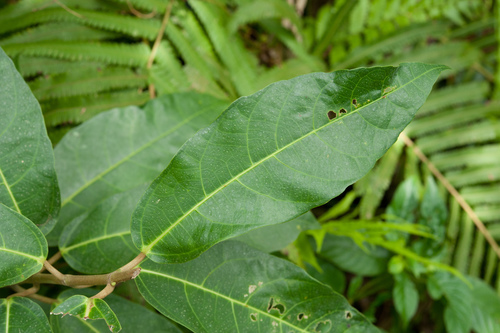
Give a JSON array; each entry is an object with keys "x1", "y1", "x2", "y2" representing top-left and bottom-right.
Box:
[{"x1": 400, "y1": 133, "x2": 500, "y2": 258}]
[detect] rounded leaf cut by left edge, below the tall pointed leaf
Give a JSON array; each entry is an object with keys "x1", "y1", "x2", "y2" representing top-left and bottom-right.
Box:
[{"x1": 0, "y1": 204, "x2": 48, "y2": 287}]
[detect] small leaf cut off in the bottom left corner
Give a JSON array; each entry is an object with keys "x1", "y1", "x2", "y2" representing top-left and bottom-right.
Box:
[{"x1": 0, "y1": 297, "x2": 52, "y2": 333}]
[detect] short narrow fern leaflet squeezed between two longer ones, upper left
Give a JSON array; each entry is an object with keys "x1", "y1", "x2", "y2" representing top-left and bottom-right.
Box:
[{"x1": 18, "y1": 55, "x2": 106, "y2": 78}]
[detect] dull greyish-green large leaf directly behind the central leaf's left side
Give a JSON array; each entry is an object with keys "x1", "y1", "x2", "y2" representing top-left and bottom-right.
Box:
[{"x1": 48, "y1": 93, "x2": 227, "y2": 243}]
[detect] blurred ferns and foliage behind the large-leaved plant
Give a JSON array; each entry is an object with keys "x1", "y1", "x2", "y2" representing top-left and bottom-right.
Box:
[{"x1": 0, "y1": 0, "x2": 500, "y2": 332}]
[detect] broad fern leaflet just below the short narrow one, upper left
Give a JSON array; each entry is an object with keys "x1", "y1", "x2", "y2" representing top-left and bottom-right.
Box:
[{"x1": 29, "y1": 68, "x2": 147, "y2": 101}]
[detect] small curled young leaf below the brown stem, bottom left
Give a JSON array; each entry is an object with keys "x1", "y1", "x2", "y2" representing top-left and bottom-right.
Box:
[{"x1": 50, "y1": 295, "x2": 122, "y2": 332}]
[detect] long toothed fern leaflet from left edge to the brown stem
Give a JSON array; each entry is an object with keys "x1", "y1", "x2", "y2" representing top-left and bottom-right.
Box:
[{"x1": 3, "y1": 41, "x2": 150, "y2": 67}]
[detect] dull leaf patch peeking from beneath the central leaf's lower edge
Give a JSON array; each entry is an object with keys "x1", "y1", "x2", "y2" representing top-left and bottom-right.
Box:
[{"x1": 235, "y1": 212, "x2": 321, "y2": 253}]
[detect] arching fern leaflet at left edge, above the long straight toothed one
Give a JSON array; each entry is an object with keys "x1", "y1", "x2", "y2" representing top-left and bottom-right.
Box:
[{"x1": 0, "y1": 23, "x2": 120, "y2": 46}]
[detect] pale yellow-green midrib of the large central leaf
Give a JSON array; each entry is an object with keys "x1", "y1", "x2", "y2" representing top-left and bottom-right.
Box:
[{"x1": 141, "y1": 67, "x2": 439, "y2": 254}]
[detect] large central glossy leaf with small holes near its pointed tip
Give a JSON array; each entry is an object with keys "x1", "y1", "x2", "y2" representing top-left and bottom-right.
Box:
[{"x1": 132, "y1": 63, "x2": 445, "y2": 262}]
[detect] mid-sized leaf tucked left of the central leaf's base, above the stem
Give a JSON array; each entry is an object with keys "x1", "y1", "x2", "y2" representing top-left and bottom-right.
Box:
[{"x1": 59, "y1": 186, "x2": 146, "y2": 274}]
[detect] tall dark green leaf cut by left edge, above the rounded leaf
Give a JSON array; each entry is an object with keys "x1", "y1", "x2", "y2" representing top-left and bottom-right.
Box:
[{"x1": 0, "y1": 48, "x2": 60, "y2": 233}]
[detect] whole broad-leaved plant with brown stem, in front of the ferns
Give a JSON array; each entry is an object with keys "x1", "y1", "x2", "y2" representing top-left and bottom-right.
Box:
[{"x1": 0, "y1": 37, "x2": 445, "y2": 332}]
